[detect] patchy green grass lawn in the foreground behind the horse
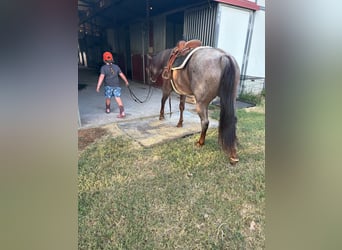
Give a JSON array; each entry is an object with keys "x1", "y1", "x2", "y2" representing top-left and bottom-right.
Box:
[{"x1": 78, "y1": 104, "x2": 265, "y2": 249}]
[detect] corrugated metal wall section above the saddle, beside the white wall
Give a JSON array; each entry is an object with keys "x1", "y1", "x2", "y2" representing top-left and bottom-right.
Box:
[{"x1": 184, "y1": 3, "x2": 217, "y2": 46}]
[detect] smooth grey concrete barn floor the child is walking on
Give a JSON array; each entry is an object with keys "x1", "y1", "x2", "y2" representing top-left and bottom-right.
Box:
[{"x1": 78, "y1": 66, "x2": 195, "y2": 128}]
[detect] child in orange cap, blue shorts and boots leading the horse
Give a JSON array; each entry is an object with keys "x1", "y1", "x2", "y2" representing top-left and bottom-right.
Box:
[{"x1": 96, "y1": 51, "x2": 129, "y2": 118}]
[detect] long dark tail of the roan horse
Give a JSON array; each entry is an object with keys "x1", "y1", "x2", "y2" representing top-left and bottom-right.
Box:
[{"x1": 218, "y1": 55, "x2": 240, "y2": 158}]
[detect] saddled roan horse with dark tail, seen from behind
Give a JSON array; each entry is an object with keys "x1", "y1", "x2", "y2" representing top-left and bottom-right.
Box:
[{"x1": 148, "y1": 47, "x2": 240, "y2": 164}]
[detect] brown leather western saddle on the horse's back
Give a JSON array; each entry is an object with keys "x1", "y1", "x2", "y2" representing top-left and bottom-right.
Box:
[{"x1": 162, "y1": 39, "x2": 202, "y2": 79}]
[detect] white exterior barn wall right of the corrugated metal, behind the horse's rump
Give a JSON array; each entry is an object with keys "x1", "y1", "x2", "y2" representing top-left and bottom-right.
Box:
[{"x1": 215, "y1": 1, "x2": 265, "y2": 94}]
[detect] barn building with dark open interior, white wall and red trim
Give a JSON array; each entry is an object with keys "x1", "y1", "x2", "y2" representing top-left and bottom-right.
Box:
[{"x1": 78, "y1": 0, "x2": 265, "y2": 92}]
